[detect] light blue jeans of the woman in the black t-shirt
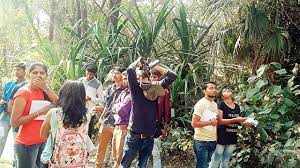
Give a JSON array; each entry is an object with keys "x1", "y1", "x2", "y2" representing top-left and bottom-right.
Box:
[{"x1": 209, "y1": 144, "x2": 235, "y2": 168}]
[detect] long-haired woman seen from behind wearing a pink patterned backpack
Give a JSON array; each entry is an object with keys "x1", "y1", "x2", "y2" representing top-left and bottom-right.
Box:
[{"x1": 40, "y1": 81, "x2": 89, "y2": 168}]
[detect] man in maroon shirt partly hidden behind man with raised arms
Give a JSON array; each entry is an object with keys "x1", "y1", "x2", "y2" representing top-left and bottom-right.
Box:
[{"x1": 151, "y1": 70, "x2": 171, "y2": 168}]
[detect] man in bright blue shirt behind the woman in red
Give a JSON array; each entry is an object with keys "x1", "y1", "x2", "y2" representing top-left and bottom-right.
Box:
[{"x1": 0, "y1": 63, "x2": 26, "y2": 156}]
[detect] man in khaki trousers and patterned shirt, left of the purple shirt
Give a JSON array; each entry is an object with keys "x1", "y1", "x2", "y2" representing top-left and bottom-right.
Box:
[{"x1": 96, "y1": 67, "x2": 124, "y2": 168}]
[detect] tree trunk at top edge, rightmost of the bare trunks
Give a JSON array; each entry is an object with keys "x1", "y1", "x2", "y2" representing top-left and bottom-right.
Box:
[{"x1": 107, "y1": 0, "x2": 121, "y2": 29}]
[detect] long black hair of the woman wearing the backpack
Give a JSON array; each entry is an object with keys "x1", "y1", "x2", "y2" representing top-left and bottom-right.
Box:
[{"x1": 56, "y1": 80, "x2": 87, "y2": 128}]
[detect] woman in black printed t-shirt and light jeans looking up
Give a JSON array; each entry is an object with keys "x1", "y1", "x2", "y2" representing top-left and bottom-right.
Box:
[{"x1": 209, "y1": 89, "x2": 250, "y2": 168}]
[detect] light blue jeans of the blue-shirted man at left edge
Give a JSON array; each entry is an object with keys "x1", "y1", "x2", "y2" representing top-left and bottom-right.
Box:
[{"x1": 0, "y1": 112, "x2": 11, "y2": 157}]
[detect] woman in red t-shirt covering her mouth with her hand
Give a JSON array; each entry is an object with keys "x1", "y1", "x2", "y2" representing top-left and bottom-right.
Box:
[{"x1": 10, "y1": 62, "x2": 57, "y2": 168}]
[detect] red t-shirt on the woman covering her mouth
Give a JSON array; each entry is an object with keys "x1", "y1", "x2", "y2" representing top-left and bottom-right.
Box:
[{"x1": 13, "y1": 84, "x2": 47, "y2": 145}]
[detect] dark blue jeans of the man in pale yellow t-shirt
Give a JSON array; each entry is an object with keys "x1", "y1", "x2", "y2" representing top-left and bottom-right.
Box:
[{"x1": 194, "y1": 140, "x2": 216, "y2": 168}]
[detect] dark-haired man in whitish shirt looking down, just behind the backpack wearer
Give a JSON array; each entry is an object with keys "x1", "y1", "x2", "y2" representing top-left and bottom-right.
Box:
[{"x1": 78, "y1": 64, "x2": 104, "y2": 138}]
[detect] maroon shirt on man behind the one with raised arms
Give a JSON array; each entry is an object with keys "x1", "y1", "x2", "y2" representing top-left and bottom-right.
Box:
[{"x1": 157, "y1": 89, "x2": 171, "y2": 124}]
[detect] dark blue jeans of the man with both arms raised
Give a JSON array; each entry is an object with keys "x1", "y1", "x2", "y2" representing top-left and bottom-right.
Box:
[{"x1": 120, "y1": 131, "x2": 154, "y2": 168}]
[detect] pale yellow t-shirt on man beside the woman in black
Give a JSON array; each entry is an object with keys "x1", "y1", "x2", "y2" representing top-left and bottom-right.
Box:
[{"x1": 193, "y1": 97, "x2": 218, "y2": 141}]
